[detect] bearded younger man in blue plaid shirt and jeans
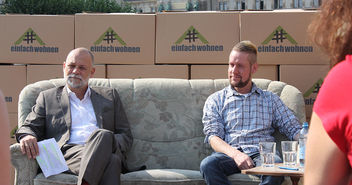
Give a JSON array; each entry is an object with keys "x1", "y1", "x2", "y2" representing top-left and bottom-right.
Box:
[{"x1": 200, "y1": 41, "x2": 301, "y2": 185}]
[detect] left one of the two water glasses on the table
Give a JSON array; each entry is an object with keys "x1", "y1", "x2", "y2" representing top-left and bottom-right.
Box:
[{"x1": 259, "y1": 142, "x2": 276, "y2": 167}]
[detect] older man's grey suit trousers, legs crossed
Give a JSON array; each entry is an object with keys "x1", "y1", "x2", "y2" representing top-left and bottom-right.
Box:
[{"x1": 61, "y1": 129, "x2": 121, "y2": 185}]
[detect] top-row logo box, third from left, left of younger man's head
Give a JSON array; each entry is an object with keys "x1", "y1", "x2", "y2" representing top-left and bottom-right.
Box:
[{"x1": 156, "y1": 12, "x2": 239, "y2": 64}]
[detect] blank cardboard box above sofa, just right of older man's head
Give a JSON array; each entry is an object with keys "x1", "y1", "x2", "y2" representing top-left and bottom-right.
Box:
[{"x1": 107, "y1": 65, "x2": 188, "y2": 79}]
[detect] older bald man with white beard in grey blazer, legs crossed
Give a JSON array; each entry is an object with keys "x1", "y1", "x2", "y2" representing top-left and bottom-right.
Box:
[{"x1": 16, "y1": 48, "x2": 133, "y2": 185}]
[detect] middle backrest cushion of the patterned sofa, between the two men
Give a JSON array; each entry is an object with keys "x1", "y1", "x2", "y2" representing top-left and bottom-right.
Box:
[{"x1": 119, "y1": 79, "x2": 214, "y2": 170}]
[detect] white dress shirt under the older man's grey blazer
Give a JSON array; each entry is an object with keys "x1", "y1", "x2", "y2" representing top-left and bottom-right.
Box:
[{"x1": 67, "y1": 87, "x2": 98, "y2": 145}]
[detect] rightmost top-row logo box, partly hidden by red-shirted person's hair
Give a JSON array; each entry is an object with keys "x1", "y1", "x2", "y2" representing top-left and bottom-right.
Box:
[{"x1": 240, "y1": 10, "x2": 329, "y2": 64}]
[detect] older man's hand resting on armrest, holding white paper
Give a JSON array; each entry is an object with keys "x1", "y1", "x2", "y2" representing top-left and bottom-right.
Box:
[{"x1": 20, "y1": 135, "x2": 39, "y2": 159}]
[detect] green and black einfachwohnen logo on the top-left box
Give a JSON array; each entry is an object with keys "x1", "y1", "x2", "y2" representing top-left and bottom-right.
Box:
[{"x1": 10, "y1": 28, "x2": 59, "y2": 53}]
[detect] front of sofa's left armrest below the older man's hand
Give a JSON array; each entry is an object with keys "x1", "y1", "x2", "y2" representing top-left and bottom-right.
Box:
[{"x1": 10, "y1": 143, "x2": 38, "y2": 185}]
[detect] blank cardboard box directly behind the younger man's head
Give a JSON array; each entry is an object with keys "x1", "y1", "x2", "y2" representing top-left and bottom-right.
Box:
[{"x1": 190, "y1": 65, "x2": 278, "y2": 80}]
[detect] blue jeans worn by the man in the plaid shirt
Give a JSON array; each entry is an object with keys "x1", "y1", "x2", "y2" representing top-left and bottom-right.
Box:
[{"x1": 200, "y1": 152, "x2": 284, "y2": 185}]
